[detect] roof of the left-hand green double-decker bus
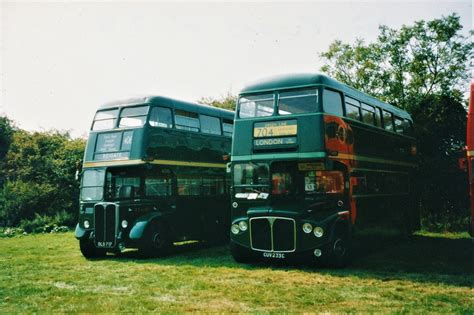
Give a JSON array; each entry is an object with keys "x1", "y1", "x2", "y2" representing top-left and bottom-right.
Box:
[{"x1": 99, "y1": 96, "x2": 234, "y2": 120}]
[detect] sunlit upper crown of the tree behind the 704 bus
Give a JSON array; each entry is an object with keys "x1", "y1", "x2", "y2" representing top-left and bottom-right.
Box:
[{"x1": 320, "y1": 14, "x2": 474, "y2": 109}]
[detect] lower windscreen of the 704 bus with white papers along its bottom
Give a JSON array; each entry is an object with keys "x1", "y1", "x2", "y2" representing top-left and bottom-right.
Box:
[{"x1": 233, "y1": 163, "x2": 269, "y2": 199}]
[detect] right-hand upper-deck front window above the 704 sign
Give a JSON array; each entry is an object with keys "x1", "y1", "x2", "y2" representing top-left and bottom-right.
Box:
[{"x1": 278, "y1": 88, "x2": 318, "y2": 115}]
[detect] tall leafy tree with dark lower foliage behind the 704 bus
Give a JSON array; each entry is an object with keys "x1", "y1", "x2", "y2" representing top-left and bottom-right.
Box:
[{"x1": 320, "y1": 14, "x2": 474, "y2": 229}]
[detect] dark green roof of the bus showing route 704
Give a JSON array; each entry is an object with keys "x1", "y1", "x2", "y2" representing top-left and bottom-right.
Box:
[{"x1": 239, "y1": 73, "x2": 411, "y2": 120}]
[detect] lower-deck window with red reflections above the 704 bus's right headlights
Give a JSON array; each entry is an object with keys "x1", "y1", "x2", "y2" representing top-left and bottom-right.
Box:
[{"x1": 304, "y1": 171, "x2": 344, "y2": 194}]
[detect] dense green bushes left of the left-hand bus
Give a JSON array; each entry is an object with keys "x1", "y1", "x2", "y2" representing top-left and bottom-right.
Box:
[{"x1": 0, "y1": 130, "x2": 85, "y2": 225}]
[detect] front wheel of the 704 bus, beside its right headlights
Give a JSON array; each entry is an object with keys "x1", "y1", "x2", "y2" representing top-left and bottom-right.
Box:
[{"x1": 323, "y1": 229, "x2": 352, "y2": 268}]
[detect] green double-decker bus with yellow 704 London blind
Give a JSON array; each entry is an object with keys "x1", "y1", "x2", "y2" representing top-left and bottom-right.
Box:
[{"x1": 230, "y1": 74, "x2": 418, "y2": 266}]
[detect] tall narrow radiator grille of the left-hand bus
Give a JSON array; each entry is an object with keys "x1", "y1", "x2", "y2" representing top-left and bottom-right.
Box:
[{"x1": 94, "y1": 204, "x2": 117, "y2": 248}]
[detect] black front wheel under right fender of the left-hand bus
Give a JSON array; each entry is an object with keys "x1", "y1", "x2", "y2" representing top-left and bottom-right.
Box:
[{"x1": 138, "y1": 222, "x2": 171, "y2": 257}]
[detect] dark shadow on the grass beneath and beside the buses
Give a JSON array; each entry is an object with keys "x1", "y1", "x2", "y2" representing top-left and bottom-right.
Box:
[{"x1": 107, "y1": 235, "x2": 474, "y2": 287}]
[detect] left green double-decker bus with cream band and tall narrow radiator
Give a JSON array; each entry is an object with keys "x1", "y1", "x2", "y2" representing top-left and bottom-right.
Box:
[{"x1": 75, "y1": 96, "x2": 234, "y2": 258}]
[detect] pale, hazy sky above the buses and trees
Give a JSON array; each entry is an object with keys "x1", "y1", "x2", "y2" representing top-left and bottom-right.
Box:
[{"x1": 0, "y1": 0, "x2": 473, "y2": 137}]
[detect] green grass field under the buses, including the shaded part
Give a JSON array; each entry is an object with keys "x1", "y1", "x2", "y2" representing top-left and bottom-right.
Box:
[{"x1": 0, "y1": 233, "x2": 474, "y2": 314}]
